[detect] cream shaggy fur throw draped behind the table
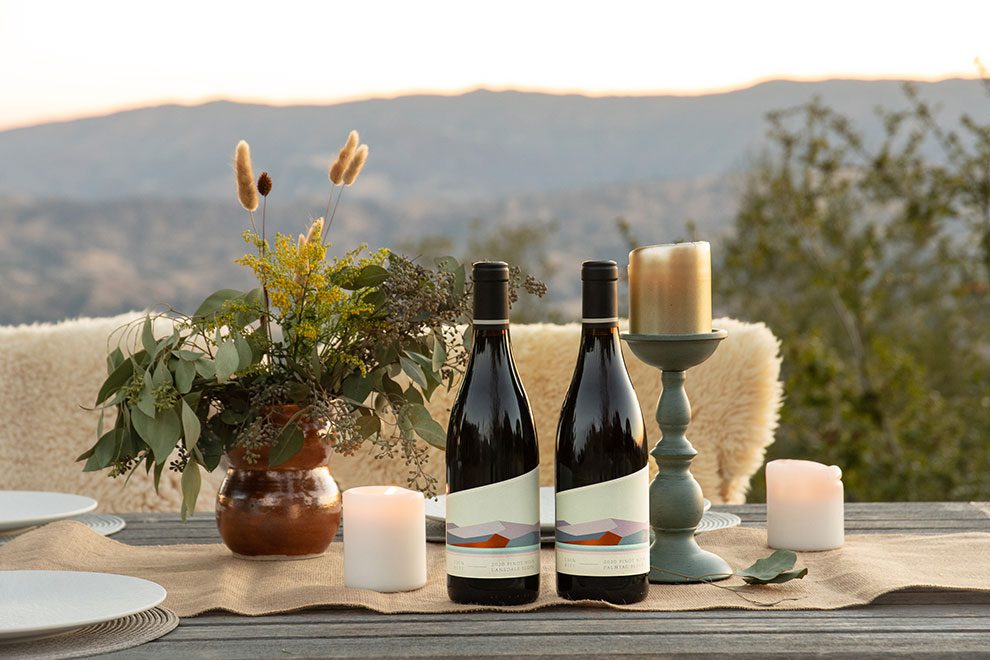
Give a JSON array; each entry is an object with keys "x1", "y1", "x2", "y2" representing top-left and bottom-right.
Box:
[{"x1": 0, "y1": 313, "x2": 782, "y2": 511}]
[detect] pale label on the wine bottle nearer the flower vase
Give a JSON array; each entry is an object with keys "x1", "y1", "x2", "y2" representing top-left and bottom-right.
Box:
[{"x1": 447, "y1": 468, "x2": 540, "y2": 578}]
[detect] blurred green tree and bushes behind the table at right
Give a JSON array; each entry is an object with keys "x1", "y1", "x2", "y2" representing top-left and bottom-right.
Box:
[{"x1": 717, "y1": 81, "x2": 990, "y2": 501}]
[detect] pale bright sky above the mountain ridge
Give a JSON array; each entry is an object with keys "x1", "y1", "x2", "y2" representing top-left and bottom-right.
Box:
[{"x1": 0, "y1": 0, "x2": 990, "y2": 129}]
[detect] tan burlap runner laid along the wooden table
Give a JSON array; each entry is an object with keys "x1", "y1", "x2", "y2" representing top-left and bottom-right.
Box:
[{"x1": 0, "y1": 521, "x2": 990, "y2": 616}]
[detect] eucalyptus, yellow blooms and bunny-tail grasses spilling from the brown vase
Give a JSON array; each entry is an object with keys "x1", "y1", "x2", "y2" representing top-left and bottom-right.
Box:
[{"x1": 78, "y1": 131, "x2": 545, "y2": 518}]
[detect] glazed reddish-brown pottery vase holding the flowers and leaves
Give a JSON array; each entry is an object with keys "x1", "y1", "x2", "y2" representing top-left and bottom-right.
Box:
[{"x1": 217, "y1": 405, "x2": 341, "y2": 559}]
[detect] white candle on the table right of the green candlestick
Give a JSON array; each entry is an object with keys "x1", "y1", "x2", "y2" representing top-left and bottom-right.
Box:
[{"x1": 767, "y1": 460, "x2": 845, "y2": 551}]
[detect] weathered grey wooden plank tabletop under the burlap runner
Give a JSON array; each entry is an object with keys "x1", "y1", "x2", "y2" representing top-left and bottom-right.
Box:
[{"x1": 108, "y1": 502, "x2": 990, "y2": 659}]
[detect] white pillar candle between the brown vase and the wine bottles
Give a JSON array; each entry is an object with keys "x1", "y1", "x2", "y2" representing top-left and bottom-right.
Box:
[{"x1": 344, "y1": 486, "x2": 426, "y2": 593}]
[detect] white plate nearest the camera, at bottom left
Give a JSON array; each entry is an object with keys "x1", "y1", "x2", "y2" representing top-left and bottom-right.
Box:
[{"x1": 0, "y1": 571, "x2": 165, "y2": 640}]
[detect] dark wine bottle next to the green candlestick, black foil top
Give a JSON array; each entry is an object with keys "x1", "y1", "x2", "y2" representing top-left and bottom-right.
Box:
[{"x1": 556, "y1": 261, "x2": 650, "y2": 603}]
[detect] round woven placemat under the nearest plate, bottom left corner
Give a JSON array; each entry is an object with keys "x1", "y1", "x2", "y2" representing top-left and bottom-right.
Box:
[{"x1": 0, "y1": 607, "x2": 179, "y2": 660}]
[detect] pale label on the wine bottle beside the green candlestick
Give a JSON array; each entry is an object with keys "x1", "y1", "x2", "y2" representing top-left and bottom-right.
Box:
[{"x1": 556, "y1": 467, "x2": 650, "y2": 577}]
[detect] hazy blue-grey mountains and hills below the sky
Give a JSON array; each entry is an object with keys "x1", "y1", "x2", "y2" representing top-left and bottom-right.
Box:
[{"x1": 0, "y1": 80, "x2": 987, "y2": 324}]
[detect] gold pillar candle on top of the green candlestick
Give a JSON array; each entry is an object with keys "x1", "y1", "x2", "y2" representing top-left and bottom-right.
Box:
[{"x1": 629, "y1": 241, "x2": 712, "y2": 335}]
